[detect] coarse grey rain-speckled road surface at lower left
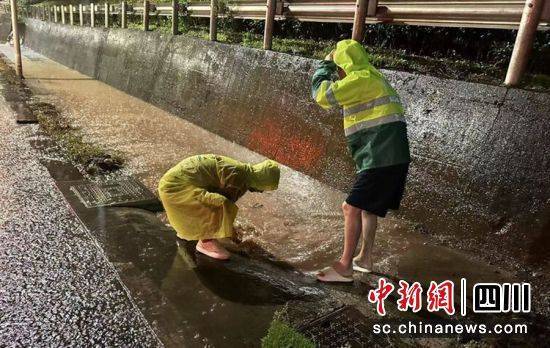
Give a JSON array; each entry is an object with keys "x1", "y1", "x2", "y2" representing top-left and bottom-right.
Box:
[{"x1": 0, "y1": 98, "x2": 162, "y2": 347}]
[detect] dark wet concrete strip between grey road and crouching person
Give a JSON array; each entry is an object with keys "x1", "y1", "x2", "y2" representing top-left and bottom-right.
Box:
[{"x1": 44, "y1": 161, "x2": 323, "y2": 347}]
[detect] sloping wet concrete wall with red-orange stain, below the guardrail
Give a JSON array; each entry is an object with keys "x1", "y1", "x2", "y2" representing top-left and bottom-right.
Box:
[{"x1": 21, "y1": 19, "x2": 550, "y2": 258}]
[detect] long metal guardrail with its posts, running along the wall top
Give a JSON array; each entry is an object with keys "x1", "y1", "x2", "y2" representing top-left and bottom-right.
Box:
[{"x1": 7, "y1": 0, "x2": 550, "y2": 85}]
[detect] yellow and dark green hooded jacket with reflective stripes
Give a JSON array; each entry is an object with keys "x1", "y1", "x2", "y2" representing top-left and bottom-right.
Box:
[{"x1": 311, "y1": 40, "x2": 410, "y2": 172}]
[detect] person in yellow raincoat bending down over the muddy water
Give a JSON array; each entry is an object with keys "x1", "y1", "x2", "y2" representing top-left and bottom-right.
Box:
[{"x1": 158, "y1": 154, "x2": 280, "y2": 260}]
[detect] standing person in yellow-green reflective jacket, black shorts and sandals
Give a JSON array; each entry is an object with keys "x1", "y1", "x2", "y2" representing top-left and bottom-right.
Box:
[{"x1": 311, "y1": 40, "x2": 410, "y2": 282}]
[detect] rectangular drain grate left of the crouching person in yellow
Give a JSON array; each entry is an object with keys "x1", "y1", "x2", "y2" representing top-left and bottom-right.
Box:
[{"x1": 71, "y1": 178, "x2": 156, "y2": 208}]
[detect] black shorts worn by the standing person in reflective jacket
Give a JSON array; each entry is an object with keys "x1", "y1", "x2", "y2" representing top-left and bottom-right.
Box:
[{"x1": 346, "y1": 163, "x2": 409, "y2": 217}]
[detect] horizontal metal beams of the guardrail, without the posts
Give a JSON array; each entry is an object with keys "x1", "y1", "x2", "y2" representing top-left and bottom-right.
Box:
[{"x1": 186, "y1": 0, "x2": 550, "y2": 30}]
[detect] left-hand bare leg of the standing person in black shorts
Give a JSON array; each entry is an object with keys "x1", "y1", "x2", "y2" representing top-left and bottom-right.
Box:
[{"x1": 333, "y1": 203, "x2": 362, "y2": 276}]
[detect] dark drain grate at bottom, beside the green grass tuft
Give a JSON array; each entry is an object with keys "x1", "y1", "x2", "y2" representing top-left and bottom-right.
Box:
[{"x1": 299, "y1": 306, "x2": 373, "y2": 348}]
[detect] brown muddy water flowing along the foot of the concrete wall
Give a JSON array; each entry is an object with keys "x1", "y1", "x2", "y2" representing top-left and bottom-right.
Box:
[{"x1": 5, "y1": 45, "x2": 532, "y2": 271}]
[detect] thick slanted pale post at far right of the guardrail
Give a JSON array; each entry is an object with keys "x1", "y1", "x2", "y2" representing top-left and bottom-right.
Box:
[{"x1": 504, "y1": 0, "x2": 544, "y2": 86}]
